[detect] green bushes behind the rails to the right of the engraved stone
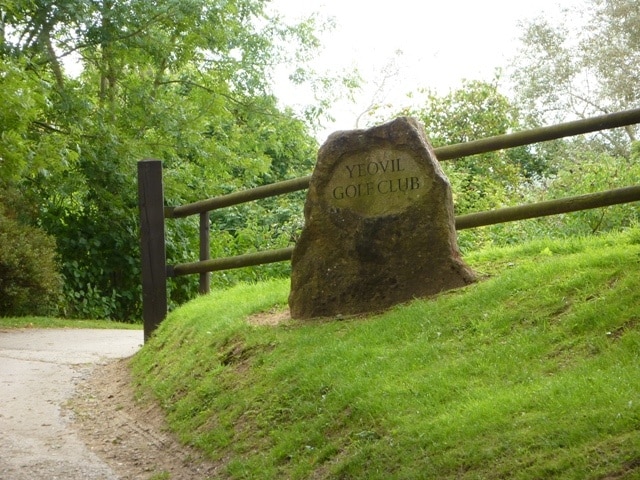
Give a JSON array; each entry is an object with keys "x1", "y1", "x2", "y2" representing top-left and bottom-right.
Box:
[{"x1": 392, "y1": 78, "x2": 640, "y2": 252}]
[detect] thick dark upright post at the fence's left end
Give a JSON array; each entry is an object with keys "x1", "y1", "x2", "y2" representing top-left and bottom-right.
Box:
[{"x1": 138, "y1": 160, "x2": 167, "y2": 342}]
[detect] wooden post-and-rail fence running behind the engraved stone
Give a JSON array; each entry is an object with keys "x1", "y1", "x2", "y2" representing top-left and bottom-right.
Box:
[{"x1": 138, "y1": 109, "x2": 640, "y2": 340}]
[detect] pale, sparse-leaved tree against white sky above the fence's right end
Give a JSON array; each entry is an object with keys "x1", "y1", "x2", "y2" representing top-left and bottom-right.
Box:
[{"x1": 513, "y1": 0, "x2": 640, "y2": 156}]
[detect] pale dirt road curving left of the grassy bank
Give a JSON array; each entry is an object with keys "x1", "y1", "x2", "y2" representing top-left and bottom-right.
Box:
[{"x1": 0, "y1": 329, "x2": 143, "y2": 480}]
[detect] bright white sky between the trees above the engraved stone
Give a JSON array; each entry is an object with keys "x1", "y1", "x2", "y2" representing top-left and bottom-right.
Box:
[{"x1": 272, "y1": 0, "x2": 581, "y2": 142}]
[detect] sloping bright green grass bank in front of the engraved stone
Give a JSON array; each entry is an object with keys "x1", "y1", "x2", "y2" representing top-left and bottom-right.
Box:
[{"x1": 133, "y1": 229, "x2": 640, "y2": 479}]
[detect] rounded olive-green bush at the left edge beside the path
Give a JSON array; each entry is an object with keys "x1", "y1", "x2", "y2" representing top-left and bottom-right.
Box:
[{"x1": 0, "y1": 210, "x2": 62, "y2": 317}]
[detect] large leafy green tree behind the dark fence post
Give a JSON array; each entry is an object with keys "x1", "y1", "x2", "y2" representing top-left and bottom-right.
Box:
[{"x1": 0, "y1": 0, "x2": 324, "y2": 320}]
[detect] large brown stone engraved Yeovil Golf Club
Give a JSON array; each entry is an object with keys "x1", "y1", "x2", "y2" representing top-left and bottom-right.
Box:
[{"x1": 289, "y1": 118, "x2": 475, "y2": 319}]
